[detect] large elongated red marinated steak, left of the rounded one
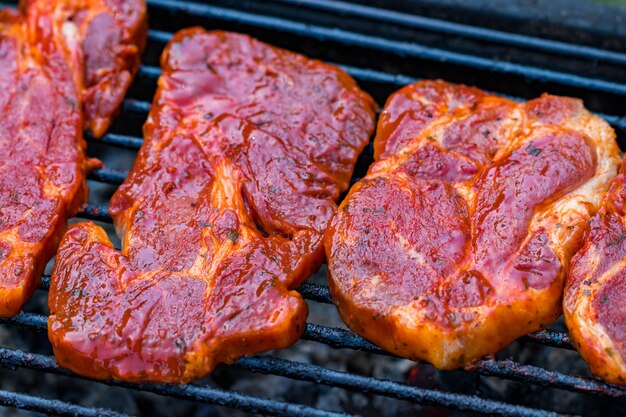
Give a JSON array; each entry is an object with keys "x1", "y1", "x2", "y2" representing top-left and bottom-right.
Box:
[{"x1": 49, "y1": 28, "x2": 375, "y2": 382}]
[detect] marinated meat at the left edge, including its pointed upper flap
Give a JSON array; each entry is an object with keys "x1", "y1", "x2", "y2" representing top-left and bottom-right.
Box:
[{"x1": 0, "y1": 0, "x2": 146, "y2": 316}]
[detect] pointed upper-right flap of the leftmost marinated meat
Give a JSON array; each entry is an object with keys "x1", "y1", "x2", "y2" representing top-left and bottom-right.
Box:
[{"x1": 20, "y1": 0, "x2": 148, "y2": 137}]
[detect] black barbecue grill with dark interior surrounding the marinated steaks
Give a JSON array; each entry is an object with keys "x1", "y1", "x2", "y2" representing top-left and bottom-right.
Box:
[{"x1": 0, "y1": 0, "x2": 626, "y2": 417}]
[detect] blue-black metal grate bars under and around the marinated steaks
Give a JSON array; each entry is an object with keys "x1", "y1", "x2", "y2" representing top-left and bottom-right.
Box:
[{"x1": 0, "y1": 0, "x2": 626, "y2": 416}]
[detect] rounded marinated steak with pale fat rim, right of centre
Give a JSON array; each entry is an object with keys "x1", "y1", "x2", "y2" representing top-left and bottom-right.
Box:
[{"x1": 325, "y1": 81, "x2": 619, "y2": 369}]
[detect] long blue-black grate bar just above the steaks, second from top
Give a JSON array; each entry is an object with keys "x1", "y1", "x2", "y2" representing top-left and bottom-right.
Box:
[{"x1": 148, "y1": 0, "x2": 626, "y2": 95}]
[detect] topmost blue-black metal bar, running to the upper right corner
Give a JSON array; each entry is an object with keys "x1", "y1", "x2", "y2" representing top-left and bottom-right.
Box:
[{"x1": 275, "y1": 0, "x2": 626, "y2": 65}]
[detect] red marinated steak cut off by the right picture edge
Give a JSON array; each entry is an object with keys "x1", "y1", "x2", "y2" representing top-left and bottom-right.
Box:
[{"x1": 563, "y1": 160, "x2": 626, "y2": 385}]
